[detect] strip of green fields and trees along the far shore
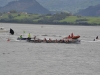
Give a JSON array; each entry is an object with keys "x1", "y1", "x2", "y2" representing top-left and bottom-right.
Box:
[{"x1": 0, "y1": 11, "x2": 100, "y2": 25}]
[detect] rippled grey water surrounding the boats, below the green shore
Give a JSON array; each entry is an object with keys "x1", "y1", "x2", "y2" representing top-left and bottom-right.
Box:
[{"x1": 0, "y1": 23, "x2": 100, "y2": 75}]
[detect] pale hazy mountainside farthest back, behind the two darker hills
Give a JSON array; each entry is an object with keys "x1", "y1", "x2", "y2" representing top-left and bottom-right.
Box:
[{"x1": 0, "y1": 0, "x2": 100, "y2": 13}]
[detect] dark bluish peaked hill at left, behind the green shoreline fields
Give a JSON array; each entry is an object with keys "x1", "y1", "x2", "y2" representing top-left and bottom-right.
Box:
[{"x1": 0, "y1": 0, "x2": 50, "y2": 14}]
